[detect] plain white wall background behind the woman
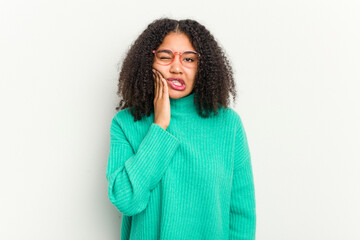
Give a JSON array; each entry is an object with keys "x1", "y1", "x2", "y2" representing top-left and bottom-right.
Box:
[{"x1": 0, "y1": 0, "x2": 360, "y2": 240}]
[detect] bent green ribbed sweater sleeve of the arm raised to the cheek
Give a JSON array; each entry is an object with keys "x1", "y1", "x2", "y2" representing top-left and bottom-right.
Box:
[{"x1": 106, "y1": 115, "x2": 180, "y2": 216}]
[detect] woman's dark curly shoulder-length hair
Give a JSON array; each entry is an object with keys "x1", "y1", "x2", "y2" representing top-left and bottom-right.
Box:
[{"x1": 116, "y1": 18, "x2": 236, "y2": 121}]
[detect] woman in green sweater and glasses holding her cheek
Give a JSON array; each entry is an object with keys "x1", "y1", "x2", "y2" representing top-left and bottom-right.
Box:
[{"x1": 106, "y1": 18, "x2": 256, "y2": 240}]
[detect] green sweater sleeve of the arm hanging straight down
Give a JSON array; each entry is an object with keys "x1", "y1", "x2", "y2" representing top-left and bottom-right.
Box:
[{"x1": 230, "y1": 117, "x2": 256, "y2": 240}]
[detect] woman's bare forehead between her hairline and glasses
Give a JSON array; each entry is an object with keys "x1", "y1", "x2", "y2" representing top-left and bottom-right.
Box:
[{"x1": 158, "y1": 32, "x2": 195, "y2": 52}]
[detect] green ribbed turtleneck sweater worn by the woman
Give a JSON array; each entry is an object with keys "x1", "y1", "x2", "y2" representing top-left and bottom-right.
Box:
[{"x1": 106, "y1": 93, "x2": 256, "y2": 240}]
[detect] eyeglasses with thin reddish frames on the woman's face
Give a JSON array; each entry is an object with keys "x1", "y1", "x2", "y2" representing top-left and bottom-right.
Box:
[{"x1": 153, "y1": 49, "x2": 200, "y2": 68}]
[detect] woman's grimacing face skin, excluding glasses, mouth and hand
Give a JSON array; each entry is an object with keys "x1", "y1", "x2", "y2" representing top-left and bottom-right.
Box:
[{"x1": 153, "y1": 32, "x2": 197, "y2": 99}]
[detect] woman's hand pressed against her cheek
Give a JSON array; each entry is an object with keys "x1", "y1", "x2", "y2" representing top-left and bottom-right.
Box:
[{"x1": 153, "y1": 69, "x2": 170, "y2": 130}]
